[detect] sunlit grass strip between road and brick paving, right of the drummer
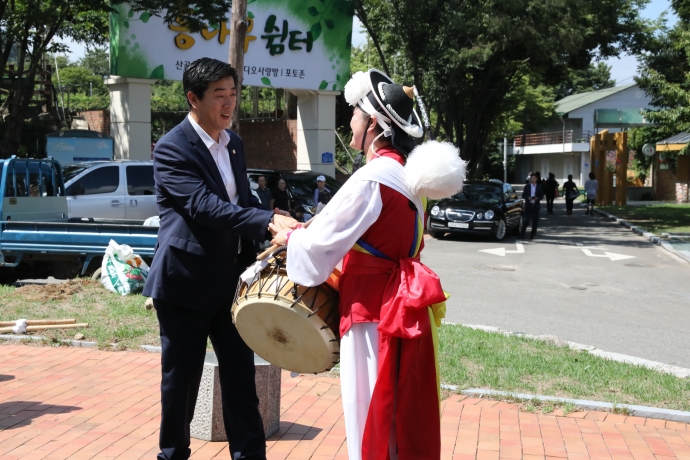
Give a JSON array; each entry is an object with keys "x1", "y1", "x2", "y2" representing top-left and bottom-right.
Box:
[{"x1": 439, "y1": 325, "x2": 690, "y2": 411}]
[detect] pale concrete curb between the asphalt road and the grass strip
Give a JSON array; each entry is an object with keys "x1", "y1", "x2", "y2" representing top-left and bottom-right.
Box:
[{"x1": 444, "y1": 321, "x2": 690, "y2": 378}]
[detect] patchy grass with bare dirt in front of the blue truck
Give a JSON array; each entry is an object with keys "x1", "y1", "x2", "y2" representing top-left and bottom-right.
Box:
[{"x1": 0, "y1": 279, "x2": 160, "y2": 349}]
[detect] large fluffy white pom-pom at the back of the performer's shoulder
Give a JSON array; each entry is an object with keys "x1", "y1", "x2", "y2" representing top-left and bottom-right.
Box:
[{"x1": 405, "y1": 141, "x2": 467, "y2": 200}]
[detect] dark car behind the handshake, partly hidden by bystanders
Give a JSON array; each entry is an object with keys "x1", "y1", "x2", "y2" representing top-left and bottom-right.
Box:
[{"x1": 247, "y1": 169, "x2": 342, "y2": 219}]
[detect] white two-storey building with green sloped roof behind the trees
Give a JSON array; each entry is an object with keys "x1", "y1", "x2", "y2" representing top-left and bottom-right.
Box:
[{"x1": 513, "y1": 84, "x2": 651, "y2": 184}]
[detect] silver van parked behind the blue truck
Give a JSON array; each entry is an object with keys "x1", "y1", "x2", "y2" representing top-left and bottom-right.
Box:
[{"x1": 63, "y1": 160, "x2": 158, "y2": 220}]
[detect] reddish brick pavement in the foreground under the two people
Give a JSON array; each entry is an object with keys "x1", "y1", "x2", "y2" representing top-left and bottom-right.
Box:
[{"x1": 0, "y1": 344, "x2": 690, "y2": 460}]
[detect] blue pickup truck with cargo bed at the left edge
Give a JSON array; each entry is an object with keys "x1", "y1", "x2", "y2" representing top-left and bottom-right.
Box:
[{"x1": 0, "y1": 156, "x2": 158, "y2": 280}]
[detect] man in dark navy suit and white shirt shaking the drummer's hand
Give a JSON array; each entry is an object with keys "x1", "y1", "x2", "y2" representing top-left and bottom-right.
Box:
[{"x1": 144, "y1": 58, "x2": 296, "y2": 460}]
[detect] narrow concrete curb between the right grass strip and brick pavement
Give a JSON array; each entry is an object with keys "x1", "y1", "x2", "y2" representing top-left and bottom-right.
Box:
[{"x1": 445, "y1": 385, "x2": 690, "y2": 423}]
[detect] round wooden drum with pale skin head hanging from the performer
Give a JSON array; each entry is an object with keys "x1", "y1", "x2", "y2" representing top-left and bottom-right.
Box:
[{"x1": 232, "y1": 248, "x2": 340, "y2": 374}]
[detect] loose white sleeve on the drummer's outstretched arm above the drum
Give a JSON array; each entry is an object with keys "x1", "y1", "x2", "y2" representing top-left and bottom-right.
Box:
[{"x1": 287, "y1": 181, "x2": 382, "y2": 286}]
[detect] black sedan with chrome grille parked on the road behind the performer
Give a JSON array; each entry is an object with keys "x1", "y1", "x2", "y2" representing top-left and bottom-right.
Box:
[{"x1": 428, "y1": 179, "x2": 525, "y2": 241}]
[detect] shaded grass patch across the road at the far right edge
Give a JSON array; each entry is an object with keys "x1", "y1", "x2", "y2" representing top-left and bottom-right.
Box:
[{"x1": 598, "y1": 204, "x2": 690, "y2": 234}]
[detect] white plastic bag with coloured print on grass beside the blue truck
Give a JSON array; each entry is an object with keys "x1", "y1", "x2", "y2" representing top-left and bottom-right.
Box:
[{"x1": 101, "y1": 240, "x2": 149, "y2": 295}]
